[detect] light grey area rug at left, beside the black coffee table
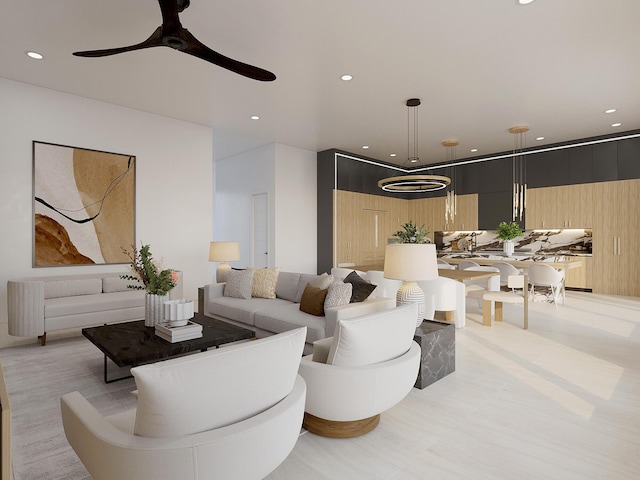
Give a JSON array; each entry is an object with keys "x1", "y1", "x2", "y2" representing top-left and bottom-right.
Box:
[{"x1": 0, "y1": 336, "x2": 135, "y2": 480}]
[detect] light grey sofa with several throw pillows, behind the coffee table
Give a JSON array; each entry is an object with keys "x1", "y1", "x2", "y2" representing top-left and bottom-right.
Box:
[{"x1": 204, "y1": 269, "x2": 396, "y2": 353}]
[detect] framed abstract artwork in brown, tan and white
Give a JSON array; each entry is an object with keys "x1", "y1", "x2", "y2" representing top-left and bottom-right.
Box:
[{"x1": 33, "y1": 141, "x2": 136, "y2": 267}]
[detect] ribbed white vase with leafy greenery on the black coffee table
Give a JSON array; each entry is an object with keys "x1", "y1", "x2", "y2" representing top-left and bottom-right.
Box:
[{"x1": 120, "y1": 245, "x2": 178, "y2": 327}]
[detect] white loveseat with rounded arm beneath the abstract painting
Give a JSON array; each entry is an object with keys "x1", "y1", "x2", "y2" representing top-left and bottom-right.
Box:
[{"x1": 7, "y1": 272, "x2": 182, "y2": 345}]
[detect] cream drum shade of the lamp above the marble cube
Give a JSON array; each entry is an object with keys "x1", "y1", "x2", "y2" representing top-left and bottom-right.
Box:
[{"x1": 384, "y1": 243, "x2": 438, "y2": 282}]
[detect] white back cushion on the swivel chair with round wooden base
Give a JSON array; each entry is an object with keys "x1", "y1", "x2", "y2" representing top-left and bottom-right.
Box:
[{"x1": 327, "y1": 304, "x2": 418, "y2": 366}]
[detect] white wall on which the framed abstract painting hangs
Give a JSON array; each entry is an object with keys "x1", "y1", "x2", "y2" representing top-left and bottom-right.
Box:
[{"x1": 0, "y1": 78, "x2": 213, "y2": 328}]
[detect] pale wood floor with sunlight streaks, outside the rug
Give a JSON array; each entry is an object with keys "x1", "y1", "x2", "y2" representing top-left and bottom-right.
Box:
[{"x1": 0, "y1": 292, "x2": 640, "y2": 480}]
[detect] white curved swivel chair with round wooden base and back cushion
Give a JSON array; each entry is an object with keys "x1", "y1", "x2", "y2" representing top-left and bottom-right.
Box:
[{"x1": 298, "y1": 304, "x2": 421, "y2": 438}]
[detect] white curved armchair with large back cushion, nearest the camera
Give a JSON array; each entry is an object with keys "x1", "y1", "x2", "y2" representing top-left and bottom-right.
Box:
[{"x1": 60, "y1": 328, "x2": 306, "y2": 480}]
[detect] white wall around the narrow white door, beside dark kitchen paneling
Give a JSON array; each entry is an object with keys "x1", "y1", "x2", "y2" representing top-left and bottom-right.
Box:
[{"x1": 213, "y1": 144, "x2": 317, "y2": 273}]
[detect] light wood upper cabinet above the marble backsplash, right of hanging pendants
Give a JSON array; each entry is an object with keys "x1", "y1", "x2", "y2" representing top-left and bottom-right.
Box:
[{"x1": 525, "y1": 183, "x2": 597, "y2": 230}]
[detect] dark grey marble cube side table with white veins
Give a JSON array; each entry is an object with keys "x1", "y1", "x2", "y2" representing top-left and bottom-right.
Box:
[{"x1": 413, "y1": 320, "x2": 456, "y2": 389}]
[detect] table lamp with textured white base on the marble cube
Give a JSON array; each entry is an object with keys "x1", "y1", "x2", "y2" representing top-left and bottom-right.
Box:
[{"x1": 384, "y1": 243, "x2": 438, "y2": 327}]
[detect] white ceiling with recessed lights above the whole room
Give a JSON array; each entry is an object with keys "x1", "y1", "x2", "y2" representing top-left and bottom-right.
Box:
[{"x1": 5, "y1": 0, "x2": 640, "y2": 164}]
